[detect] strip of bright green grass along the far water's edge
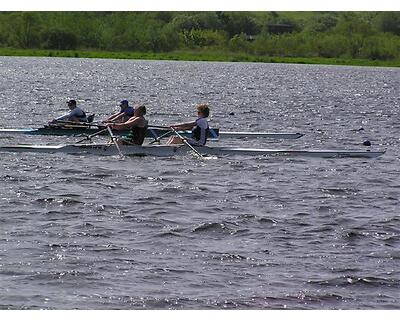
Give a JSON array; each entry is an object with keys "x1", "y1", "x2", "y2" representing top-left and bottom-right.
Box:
[{"x1": 0, "y1": 48, "x2": 400, "y2": 67}]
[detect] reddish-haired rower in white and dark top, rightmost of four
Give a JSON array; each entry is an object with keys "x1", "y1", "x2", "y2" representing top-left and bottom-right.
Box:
[{"x1": 167, "y1": 104, "x2": 210, "y2": 146}]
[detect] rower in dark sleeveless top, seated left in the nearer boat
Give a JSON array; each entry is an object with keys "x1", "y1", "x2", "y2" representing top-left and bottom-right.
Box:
[{"x1": 110, "y1": 105, "x2": 147, "y2": 145}]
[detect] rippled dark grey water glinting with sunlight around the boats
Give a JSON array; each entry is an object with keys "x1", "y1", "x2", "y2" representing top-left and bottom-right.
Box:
[{"x1": 0, "y1": 57, "x2": 400, "y2": 309}]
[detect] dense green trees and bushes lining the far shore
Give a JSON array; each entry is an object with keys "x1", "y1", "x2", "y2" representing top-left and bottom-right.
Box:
[{"x1": 0, "y1": 12, "x2": 400, "y2": 60}]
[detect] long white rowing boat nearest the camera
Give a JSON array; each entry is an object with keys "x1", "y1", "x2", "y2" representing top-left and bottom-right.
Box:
[{"x1": 0, "y1": 144, "x2": 385, "y2": 158}]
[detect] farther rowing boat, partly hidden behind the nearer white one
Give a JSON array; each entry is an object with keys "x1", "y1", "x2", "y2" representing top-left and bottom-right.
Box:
[{"x1": 0, "y1": 125, "x2": 303, "y2": 140}]
